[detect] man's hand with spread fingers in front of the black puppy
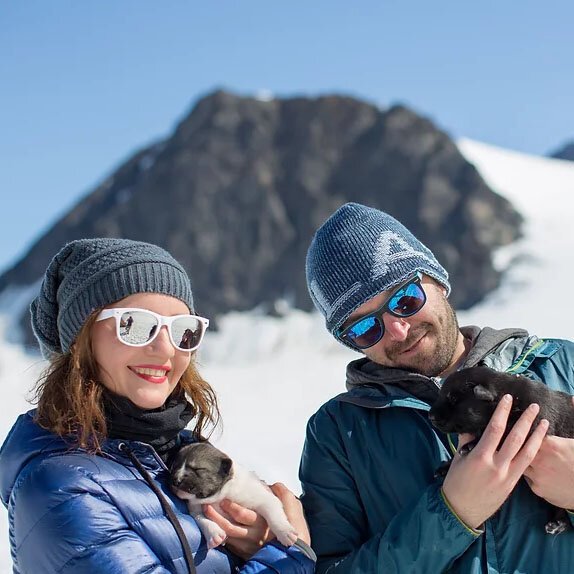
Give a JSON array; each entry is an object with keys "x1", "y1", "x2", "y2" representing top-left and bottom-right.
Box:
[{"x1": 443, "y1": 395, "x2": 548, "y2": 528}]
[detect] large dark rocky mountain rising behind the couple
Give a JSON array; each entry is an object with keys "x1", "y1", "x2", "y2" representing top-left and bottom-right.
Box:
[{"x1": 0, "y1": 91, "x2": 521, "y2": 352}]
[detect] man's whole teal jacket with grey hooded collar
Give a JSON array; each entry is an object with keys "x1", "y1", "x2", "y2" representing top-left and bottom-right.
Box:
[{"x1": 300, "y1": 327, "x2": 574, "y2": 574}]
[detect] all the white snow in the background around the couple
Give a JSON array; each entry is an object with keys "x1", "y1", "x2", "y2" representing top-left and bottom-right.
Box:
[{"x1": 0, "y1": 140, "x2": 574, "y2": 574}]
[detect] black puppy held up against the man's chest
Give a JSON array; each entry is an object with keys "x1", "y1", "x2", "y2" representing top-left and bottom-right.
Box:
[{"x1": 429, "y1": 367, "x2": 574, "y2": 534}]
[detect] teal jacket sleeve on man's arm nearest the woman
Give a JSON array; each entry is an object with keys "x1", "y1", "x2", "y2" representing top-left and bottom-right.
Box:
[{"x1": 301, "y1": 409, "x2": 479, "y2": 574}]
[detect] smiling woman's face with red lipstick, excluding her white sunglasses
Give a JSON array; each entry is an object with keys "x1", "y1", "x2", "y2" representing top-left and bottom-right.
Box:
[{"x1": 92, "y1": 293, "x2": 191, "y2": 409}]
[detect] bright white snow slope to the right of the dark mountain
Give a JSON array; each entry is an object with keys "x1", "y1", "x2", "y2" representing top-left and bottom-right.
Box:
[{"x1": 458, "y1": 139, "x2": 574, "y2": 338}]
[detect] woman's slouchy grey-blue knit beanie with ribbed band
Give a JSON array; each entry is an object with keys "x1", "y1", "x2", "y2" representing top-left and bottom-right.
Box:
[{"x1": 30, "y1": 238, "x2": 193, "y2": 358}]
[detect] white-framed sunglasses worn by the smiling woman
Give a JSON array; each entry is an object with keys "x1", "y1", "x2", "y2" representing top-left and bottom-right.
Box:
[{"x1": 96, "y1": 307, "x2": 209, "y2": 352}]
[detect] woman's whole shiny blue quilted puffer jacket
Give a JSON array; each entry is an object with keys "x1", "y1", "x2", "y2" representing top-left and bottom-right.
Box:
[{"x1": 0, "y1": 411, "x2": 314, "y2": 574}]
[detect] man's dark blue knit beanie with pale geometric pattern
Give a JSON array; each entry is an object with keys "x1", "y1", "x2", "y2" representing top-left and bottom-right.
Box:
[{"x1": 305, "y1": 203, "x2": 450, "y2": 334}]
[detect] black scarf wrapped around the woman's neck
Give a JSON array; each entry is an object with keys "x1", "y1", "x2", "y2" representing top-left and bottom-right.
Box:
[{"x1": 103, "y1": 389, "x2": 195, "y2": 461}]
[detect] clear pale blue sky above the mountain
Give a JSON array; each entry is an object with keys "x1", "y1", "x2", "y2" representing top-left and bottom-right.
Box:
[{"x1": 0, "y1": 0, "x2": 574, "y2": 270}]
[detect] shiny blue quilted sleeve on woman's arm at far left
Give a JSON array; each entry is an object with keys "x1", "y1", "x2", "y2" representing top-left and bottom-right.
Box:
[{"x1": 9, "y1": 458, "x2": 178, "y2": 574}]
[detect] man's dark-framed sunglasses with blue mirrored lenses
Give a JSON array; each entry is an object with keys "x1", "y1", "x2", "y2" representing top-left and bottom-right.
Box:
[{"x1": 335, "y1": 273, "x2": 427, "y2": 350}]
